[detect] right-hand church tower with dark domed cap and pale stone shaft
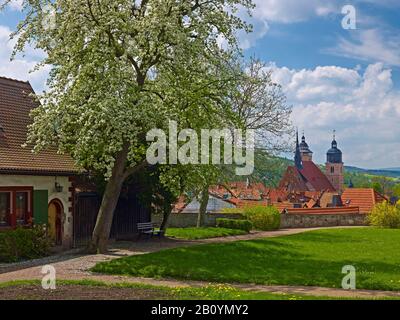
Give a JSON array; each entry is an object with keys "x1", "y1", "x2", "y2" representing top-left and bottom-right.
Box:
[{"x1": 325, "y1": 131, "x2": 344, "y2": 193}]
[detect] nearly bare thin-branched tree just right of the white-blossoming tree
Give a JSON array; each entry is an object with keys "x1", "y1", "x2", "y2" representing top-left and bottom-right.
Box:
[{"x1": 197, "y1": 58, "x2": 292, "y2": 227}]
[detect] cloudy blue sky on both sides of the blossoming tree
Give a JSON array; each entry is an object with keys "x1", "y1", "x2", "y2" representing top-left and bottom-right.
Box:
[{"x1": 0, "y1": 0, "x2": 400, "y2": 168}]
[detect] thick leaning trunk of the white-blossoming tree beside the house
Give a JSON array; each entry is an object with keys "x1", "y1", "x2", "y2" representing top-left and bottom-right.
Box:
[{"x1": 88, "y1": 145, "x2": 128, "y2": 254}]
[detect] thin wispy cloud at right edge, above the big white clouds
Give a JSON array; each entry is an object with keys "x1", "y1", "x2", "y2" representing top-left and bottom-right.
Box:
[{"x1": 325, "y1": 29, "x2": 400, "y2": 66}]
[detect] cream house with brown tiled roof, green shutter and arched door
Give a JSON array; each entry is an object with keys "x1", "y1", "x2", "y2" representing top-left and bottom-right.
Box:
[{"x1": 0, "y1": 77, "x2": 78, "y2": 246}]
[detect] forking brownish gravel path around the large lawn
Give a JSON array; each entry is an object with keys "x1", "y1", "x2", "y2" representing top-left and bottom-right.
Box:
[{"x1": 0, "y1": 228, "x2": 394, "y2": 298}]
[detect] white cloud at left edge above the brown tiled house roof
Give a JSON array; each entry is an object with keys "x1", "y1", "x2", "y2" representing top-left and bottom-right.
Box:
[{"x1": 0, "y1": 25, "x2": 49, "y2": 92}]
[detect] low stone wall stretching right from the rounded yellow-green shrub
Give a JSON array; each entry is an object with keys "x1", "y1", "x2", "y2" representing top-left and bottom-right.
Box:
[{"x1": 281, "y1": 214, "x2": 366, "y2": 228}]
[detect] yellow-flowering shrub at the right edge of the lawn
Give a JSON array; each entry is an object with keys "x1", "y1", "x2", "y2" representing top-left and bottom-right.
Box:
[{"x1": 367, "y1": 201, "x2": 400, "y2": 228}]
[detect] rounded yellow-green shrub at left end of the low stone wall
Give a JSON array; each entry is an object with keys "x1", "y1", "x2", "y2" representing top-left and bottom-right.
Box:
[{"x1": 244, "y1": 206, "x2": 281, "y2": 230}]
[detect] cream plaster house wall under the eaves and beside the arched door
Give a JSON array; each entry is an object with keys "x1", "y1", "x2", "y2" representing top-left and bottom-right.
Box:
[{"x1": 0, "y1": 174, "x2": 73, "y2": 246}]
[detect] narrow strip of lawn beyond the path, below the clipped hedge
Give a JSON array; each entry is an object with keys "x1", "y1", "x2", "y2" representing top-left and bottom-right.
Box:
[{"x1": 166, "y1": 228, "x2": 247, "y2": 240}]
